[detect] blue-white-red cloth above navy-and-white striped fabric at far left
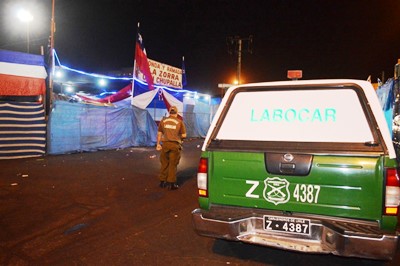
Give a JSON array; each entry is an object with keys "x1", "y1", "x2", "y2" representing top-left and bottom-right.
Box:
[{"x1": 0, "y1": 50, "x2": 47, "y2": 159}]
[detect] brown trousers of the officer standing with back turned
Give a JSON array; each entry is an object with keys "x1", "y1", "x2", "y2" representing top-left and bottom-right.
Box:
[{"x1": 160, "y1": 141, "x2": 182, "y2": 183}]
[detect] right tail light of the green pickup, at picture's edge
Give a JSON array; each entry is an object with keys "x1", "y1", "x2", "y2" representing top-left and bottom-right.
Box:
[{"x1": 385, "y1": 168, "x2": 400, "y2": 215}]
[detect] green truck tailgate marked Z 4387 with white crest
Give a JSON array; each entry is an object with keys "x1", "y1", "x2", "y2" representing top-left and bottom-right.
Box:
[{"x1": 209, "y1": 151, "x2": 383, "y2": 220}]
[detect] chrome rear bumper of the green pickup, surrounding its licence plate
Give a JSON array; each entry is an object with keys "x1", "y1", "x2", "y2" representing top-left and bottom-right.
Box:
[{"x1": 192, "y1": 207, "x2": 398, "y2": 260}]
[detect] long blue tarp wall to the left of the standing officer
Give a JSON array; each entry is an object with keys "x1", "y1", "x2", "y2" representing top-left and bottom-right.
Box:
[{"x1": 48, "y1": 101, "x2": 157, "y2": 154}]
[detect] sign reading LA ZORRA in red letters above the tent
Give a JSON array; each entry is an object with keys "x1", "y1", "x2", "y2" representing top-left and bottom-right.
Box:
[{"x1": 135, "y1": 59, "x2": 182, "y2": 89}]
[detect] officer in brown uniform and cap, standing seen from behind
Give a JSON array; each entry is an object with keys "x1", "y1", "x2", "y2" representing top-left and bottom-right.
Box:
[{"x1": 156, "y1": 106, "x2": 186, "y2": 190}]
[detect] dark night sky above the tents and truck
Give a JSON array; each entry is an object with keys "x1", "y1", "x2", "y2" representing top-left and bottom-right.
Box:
[{"x1": 0, "y1": 0, "x2": 400, "y2": 94}]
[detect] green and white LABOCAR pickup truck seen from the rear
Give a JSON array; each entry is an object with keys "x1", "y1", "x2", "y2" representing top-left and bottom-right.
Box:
[{"x1": 192, "y1": 80, "x2": 400, "y2": 260}]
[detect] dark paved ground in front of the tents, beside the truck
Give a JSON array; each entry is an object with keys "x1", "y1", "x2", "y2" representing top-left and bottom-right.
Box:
[{"x1": 0, "y1": 139, "x2": 400, "y2": 266}]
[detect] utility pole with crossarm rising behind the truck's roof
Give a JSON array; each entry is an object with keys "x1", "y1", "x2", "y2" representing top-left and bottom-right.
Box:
[{"x1": 226, "y1": 35, "x2": 253, "y2": 84}]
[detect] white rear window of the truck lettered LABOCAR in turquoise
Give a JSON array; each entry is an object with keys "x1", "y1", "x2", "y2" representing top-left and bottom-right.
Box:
[{"x1": 214, "y1": 87, "x2": 376, "y2": 143}]
